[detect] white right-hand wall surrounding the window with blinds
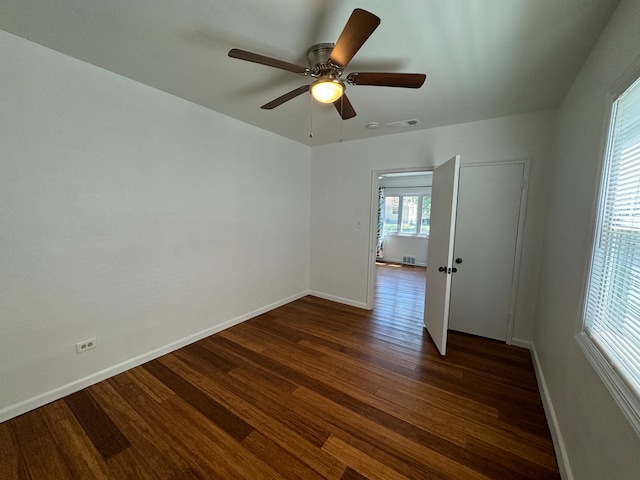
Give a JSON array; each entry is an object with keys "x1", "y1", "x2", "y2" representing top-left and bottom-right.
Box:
[{"x1": 534, "y1": 0, "x2": 640, "y2": 480}]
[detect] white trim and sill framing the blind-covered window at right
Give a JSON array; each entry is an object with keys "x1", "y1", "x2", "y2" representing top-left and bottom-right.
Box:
[{"x1": 575, "y1": 57, "x2": 640, "y2": 435}]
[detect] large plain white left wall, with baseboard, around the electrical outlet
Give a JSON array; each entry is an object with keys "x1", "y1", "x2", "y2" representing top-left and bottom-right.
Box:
[{"x1": 0, "y1": 31, "x2": 310, "y2": 421}]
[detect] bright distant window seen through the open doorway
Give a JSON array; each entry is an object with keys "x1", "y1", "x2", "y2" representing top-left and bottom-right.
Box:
[{"x1": 384, "y1": 195, "x2": 431, "y2": 236}]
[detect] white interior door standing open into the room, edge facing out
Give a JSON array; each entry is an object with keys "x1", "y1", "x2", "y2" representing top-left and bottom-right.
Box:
[{"x1": 424, "y1": 155, "x2": 460, "y2": 355}]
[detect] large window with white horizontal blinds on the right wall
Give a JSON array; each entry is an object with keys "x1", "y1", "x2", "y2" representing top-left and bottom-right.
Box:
[{"x1": 579, "y1": 72, "x2": 640, "y2": 433}]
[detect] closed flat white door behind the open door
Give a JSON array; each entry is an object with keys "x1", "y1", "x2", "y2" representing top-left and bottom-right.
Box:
[{"x1": 448, "y1": 162, "x2": 525, "y2": 341}]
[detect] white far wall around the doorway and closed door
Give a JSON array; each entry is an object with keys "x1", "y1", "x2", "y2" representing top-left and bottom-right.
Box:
[{"x1": 310, "y1": 111, "x2": 556, "y2": 342}]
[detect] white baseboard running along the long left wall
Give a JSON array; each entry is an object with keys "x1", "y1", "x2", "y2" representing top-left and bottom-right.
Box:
[{"x1": 0, "y1": 291, "x2": 309, "y2": 422}]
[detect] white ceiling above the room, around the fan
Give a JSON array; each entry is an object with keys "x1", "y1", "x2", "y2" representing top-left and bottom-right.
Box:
[{"x1": 0, "y1": 0, "x2": 619, "y2": 145}]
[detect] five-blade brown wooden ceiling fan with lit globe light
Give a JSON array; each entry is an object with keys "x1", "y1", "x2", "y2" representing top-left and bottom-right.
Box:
[{"x1": 229, "y1": 8, "x2": 427, "y2": 120}]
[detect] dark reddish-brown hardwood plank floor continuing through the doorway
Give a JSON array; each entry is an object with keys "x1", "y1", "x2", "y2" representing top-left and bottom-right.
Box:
[{"x1": 0, "y1": 266, "x2": 559, "y2": 480}]
